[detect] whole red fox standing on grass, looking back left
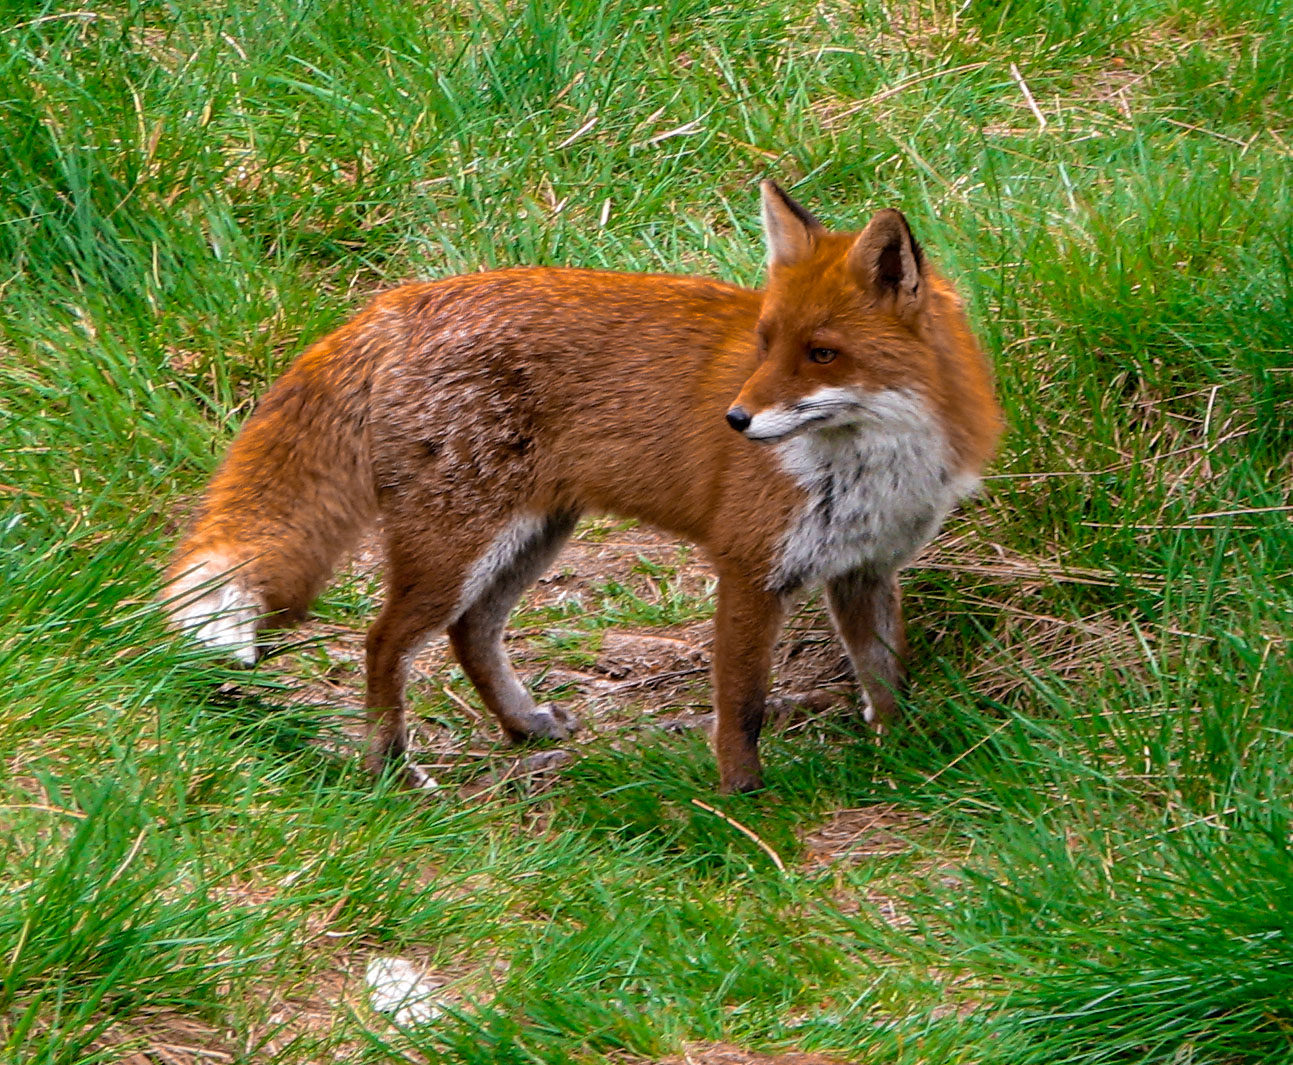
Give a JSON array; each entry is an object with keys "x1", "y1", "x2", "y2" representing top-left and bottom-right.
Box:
[{"x1": 167, "y1": 182, "x2": 1001, "y2": 791}]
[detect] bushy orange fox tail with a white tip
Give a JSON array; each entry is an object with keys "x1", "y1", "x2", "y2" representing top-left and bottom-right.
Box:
[{"x1": 164, "y1": 313, "x2": 383, "y2": 664}]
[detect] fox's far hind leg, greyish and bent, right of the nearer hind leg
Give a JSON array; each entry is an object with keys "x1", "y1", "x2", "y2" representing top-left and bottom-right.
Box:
[{"x1": 449, "y1": 512, "x2": 578, "y2": 742}]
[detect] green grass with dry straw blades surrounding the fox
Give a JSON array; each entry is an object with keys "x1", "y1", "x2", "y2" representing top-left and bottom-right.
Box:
[{"x1": 0, "y1": 0, "x2": 1293, "y2": 1065}]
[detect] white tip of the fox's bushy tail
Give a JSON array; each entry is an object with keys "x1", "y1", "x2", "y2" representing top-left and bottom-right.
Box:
[{"x1": 166, "y1": 557, "x2": 266, "y2": 666}]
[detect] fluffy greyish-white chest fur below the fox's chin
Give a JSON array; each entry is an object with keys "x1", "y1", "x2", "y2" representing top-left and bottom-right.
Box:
[{"x1": 771, "y1": 389, "x2": 978, "y2": 588}]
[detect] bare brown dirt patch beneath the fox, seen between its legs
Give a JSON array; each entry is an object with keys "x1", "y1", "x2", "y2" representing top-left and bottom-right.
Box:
[{"x1": 279, "y1": 522, "x2": 856, "y2": 786}]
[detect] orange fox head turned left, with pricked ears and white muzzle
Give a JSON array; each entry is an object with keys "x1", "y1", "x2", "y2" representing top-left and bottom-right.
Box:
[{"x1": 727, "y1": 181, "x2": 931, "y2": 443}]
